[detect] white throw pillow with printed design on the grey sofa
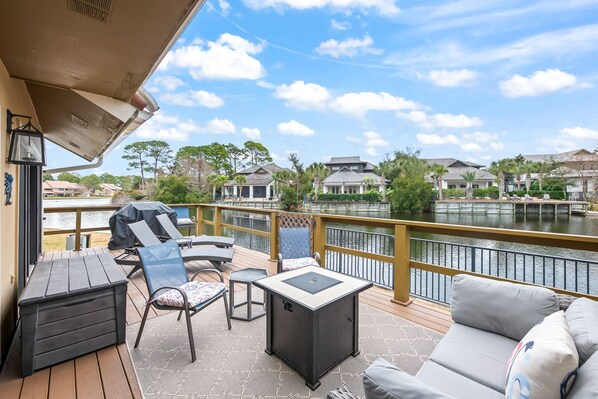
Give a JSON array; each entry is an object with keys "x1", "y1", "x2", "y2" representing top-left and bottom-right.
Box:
[{"x1": 505, "y1": 311, "x2": 579, "y2": 399}]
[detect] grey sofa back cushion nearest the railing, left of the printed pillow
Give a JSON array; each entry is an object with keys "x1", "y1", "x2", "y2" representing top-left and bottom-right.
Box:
[{"x1": 451, "y1": 274, "x2": 559, "y2": 341}]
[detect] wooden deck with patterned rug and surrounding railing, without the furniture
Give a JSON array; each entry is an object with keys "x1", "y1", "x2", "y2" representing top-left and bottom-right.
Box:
[{"x1": 0, "y1": 204, "x2": 598, "y2": 398}]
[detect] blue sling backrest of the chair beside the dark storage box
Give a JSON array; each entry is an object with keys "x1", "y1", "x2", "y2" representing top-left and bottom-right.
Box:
[{"x1": 138, "y1": 241, "x2": 189, "y2": 294}]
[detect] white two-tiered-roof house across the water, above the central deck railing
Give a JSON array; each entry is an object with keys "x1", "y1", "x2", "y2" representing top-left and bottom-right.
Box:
[{"x1": 322, "y1": 156, "x2": 386, "y2": 194}]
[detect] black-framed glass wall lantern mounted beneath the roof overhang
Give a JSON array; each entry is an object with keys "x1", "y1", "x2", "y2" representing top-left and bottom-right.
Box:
[{"x1": 6, "y1": 110, "x2": 46, "y2": 166}]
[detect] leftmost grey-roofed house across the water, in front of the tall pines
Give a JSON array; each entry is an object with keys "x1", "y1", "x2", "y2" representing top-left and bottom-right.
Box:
[{"x1": 224, "y1": 163, "x2": 290, "y2": 200}]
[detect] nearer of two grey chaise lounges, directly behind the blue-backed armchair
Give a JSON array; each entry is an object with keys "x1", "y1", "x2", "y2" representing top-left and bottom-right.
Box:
[{"x1": 128, "y1": 220, "x2": 234, "y2": 276}]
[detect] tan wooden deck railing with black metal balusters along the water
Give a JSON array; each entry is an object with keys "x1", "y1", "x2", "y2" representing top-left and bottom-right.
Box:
[{"x1": 44, "y1": 204, "x2": 598, "y2": 304}]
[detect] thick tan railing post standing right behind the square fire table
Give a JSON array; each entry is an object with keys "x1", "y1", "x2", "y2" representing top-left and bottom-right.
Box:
[{"x1": 392, "y1": 224, "x2": 412, "y2": 306}]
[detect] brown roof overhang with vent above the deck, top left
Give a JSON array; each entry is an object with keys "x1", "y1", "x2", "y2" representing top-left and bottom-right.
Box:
[{"x1": 0, "y1": 0, "x2": 205, "y2": 160}]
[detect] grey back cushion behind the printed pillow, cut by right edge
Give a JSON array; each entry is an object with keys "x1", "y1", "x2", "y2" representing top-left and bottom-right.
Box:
[{"x1": 565, "y1": 298, "x2": 598, "y2": 365}]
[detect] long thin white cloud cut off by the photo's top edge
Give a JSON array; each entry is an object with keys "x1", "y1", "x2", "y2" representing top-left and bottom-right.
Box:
[{"x1": 243, "y1": 0, "x2": 400, "y2": 17}]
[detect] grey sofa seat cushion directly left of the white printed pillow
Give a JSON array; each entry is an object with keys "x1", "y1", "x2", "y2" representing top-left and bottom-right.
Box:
[{"x1": 430, "y1": 324, "x2": 518, "y2": 393}]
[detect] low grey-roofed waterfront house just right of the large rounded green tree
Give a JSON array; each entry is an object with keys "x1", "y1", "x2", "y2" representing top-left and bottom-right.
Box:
[{"x1": 424, "y1": 158, "x2": 496, "y2": 189}]
